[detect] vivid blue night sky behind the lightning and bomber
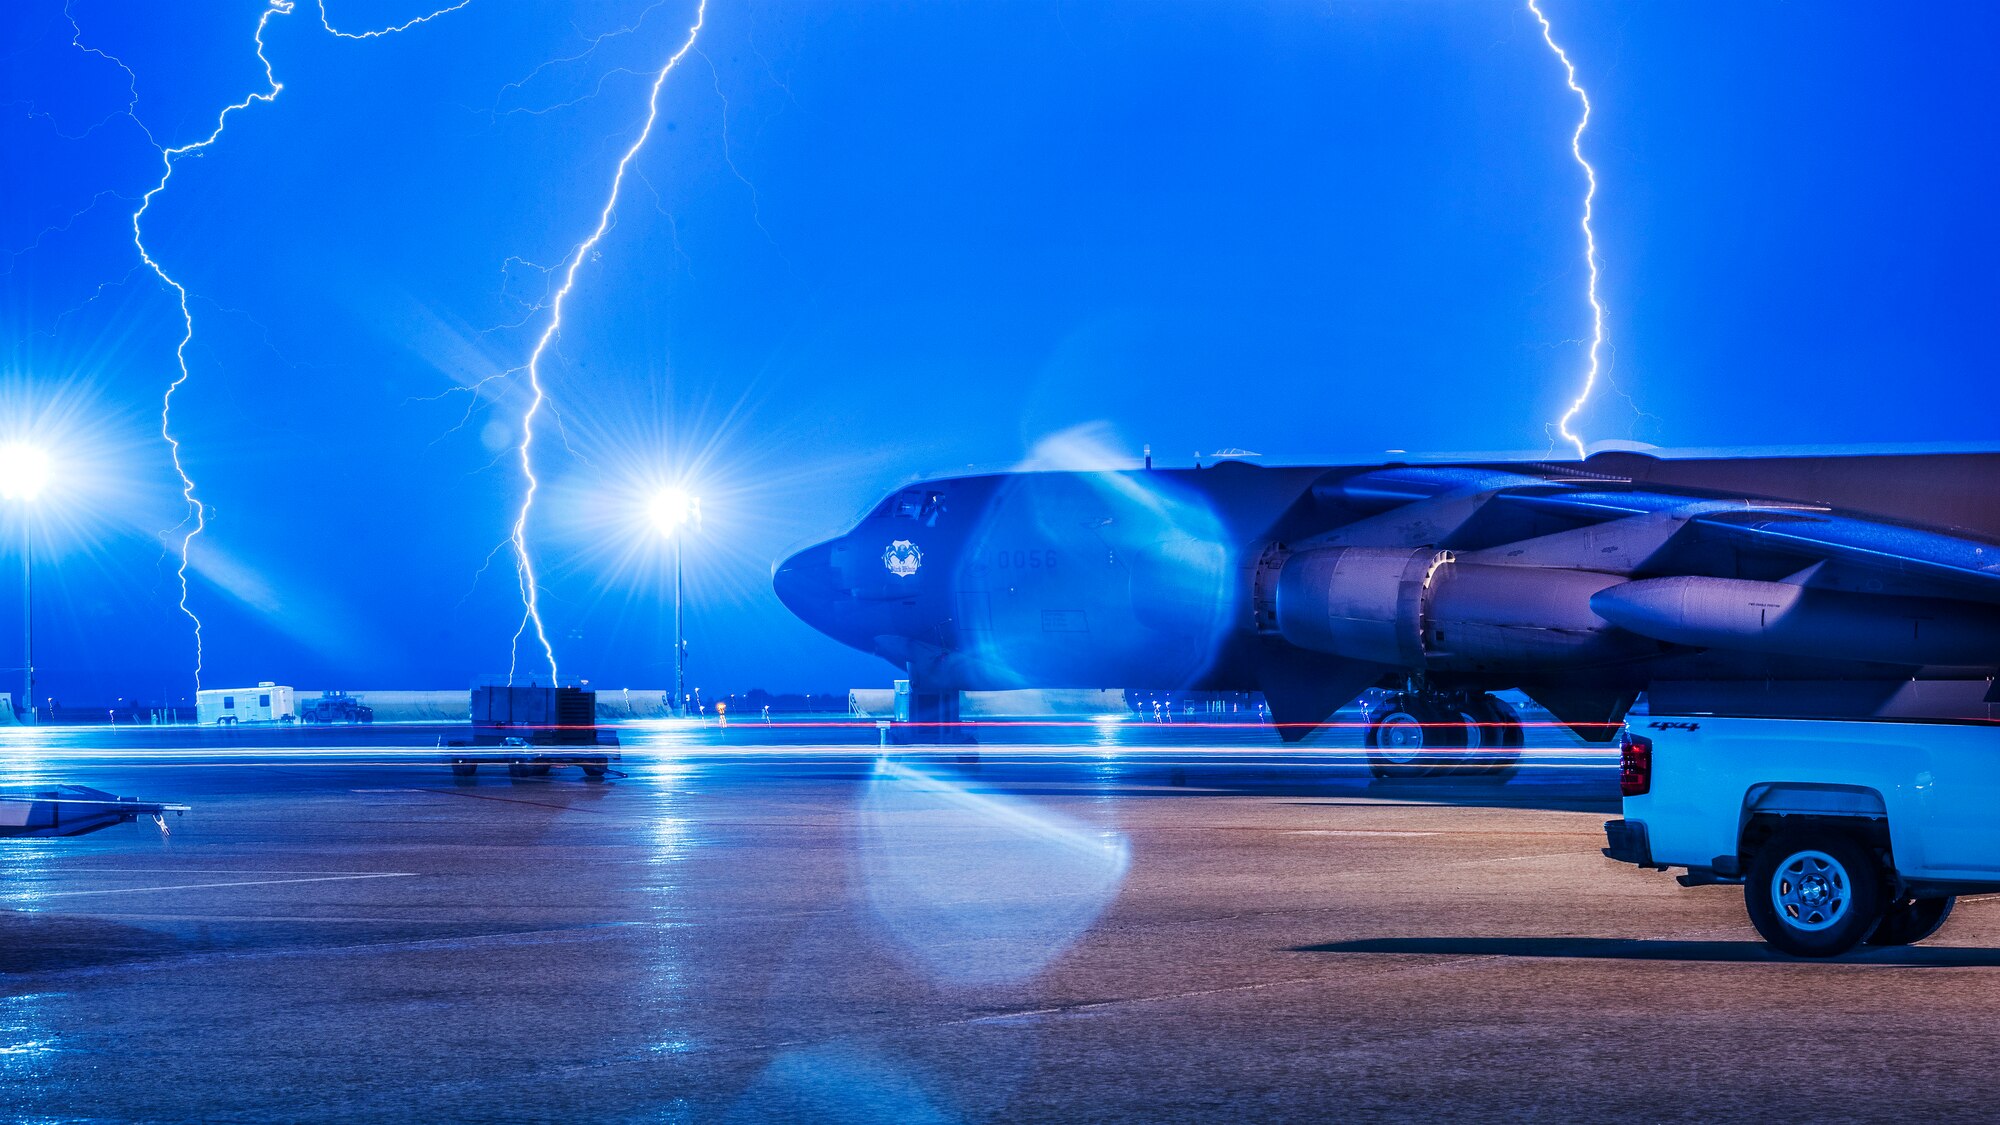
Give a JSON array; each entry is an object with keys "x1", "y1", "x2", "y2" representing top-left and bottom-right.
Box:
[{"x1": 0, "y1": 0, "x2": 2000, "y2": 701}]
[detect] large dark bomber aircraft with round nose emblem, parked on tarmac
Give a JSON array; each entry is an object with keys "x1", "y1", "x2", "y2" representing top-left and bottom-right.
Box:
[{"x1": 774, "y1": 450, "x2": 2000, "y2": 771}]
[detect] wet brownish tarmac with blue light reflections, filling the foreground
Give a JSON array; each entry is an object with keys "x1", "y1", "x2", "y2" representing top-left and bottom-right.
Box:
[{"x1": 0, "y1": 731, "x2": 2000, "y2": 1121}]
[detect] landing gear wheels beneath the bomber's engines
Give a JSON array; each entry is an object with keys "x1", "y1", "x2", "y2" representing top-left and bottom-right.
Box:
[{"x1": 1366, "y1": 691, "x2": 1526, "y2": 779}]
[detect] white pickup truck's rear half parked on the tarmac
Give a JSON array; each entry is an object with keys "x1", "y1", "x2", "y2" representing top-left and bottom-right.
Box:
[{"x1": 1604, "y1": 715, "x2": 2000, "y2": 957}]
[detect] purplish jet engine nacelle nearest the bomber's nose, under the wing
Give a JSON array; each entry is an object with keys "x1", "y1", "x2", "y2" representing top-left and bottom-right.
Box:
[{"x1": 1268, "y1": 546, "x2": 1658, "y2": 671}]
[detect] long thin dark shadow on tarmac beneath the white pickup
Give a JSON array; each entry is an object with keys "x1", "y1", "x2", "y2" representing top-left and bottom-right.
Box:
[{"x1": 1292, "y1": 937, "x2": 2000, "y2": 969}]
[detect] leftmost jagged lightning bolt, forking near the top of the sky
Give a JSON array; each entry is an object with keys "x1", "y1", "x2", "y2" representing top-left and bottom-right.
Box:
[{"x1": 102, "y1": 0, "x2": 472, "y2": 691}]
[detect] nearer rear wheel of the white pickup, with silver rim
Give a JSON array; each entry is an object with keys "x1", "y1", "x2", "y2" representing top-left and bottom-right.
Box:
[{"x1": 1744, "y1": 829, "x2": 1882, "y2": 957}]
